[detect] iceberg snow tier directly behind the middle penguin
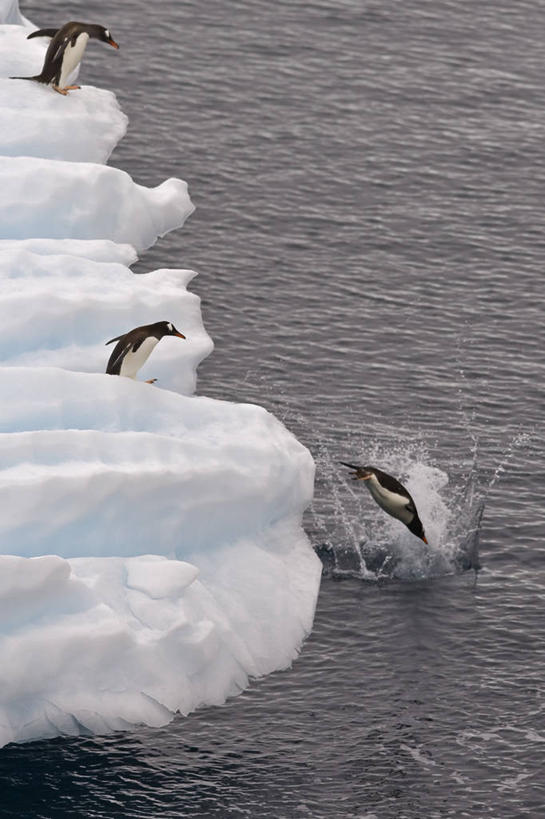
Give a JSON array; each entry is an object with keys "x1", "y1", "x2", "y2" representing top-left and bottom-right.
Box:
[{"x1": 0, "y1": 248, "x2": 212, "y2": 395}]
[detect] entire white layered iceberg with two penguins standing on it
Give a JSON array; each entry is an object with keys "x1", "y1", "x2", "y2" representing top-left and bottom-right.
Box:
[{"x1": 0, "y1": 0, "x2": 321, "y2": 745}]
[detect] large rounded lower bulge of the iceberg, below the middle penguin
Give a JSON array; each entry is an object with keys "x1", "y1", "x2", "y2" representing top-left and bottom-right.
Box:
[{"x1": 0, "y1": 367, "x2": 321, "y2": 744}]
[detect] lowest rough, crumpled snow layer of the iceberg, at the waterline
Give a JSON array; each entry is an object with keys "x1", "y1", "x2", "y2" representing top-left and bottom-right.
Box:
[{"x1": 0, "y1": 520, "x2": 320, "y2": 745}]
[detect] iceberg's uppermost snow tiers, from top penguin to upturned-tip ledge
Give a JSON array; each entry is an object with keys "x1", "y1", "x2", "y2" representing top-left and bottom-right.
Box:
[{"x1": 0, "y1": 20, "x2": 193, "y2": 251}]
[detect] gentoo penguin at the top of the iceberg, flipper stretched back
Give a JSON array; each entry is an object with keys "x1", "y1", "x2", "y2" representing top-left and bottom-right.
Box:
[{"x1": 10, "y1": 22, "x2": 119, "y2": 95}]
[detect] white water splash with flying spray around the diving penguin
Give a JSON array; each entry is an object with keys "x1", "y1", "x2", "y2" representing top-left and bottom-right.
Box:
[{"x1": 209, "y1": 368, "x2": 532, "y2": 582}]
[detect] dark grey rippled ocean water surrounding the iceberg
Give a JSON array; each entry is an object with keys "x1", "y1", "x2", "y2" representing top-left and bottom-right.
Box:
[{"x1": 4, "y1": 0, "x2": 545, "y2": 819}]
